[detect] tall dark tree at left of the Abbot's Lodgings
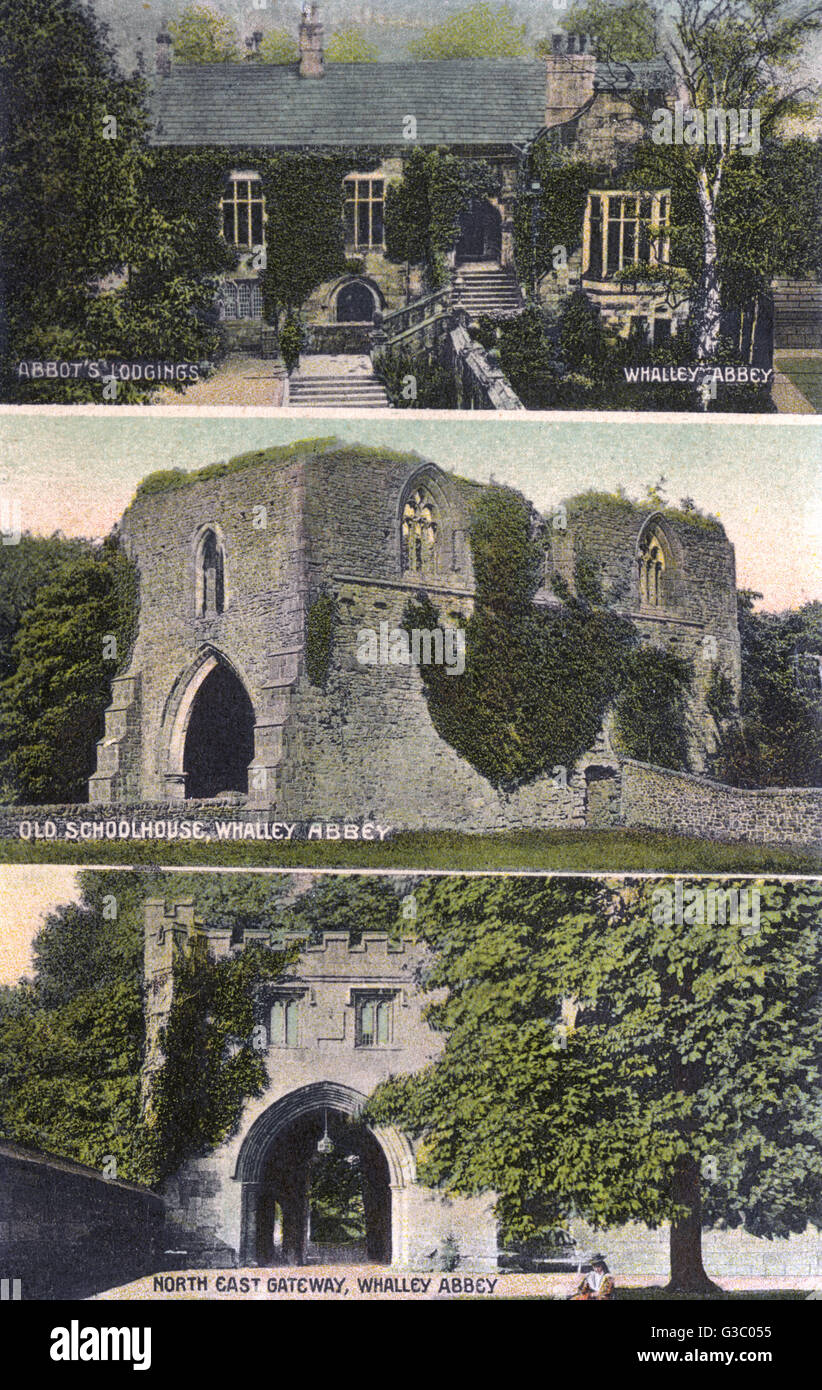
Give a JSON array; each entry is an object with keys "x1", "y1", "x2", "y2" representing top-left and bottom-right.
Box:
[{"x1": 0, "y1": 0, "x2": 228, "y2": 400}]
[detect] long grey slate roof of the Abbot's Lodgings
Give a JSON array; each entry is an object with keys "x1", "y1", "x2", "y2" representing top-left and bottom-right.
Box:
[{"x1": 149, "y1": 58, "x2": 664, "y2": 149}]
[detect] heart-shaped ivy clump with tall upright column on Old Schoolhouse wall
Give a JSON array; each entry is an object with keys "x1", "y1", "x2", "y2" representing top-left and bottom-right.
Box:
[{"x1": 403, "y1": 487, "x2": 633, "y2": 790}]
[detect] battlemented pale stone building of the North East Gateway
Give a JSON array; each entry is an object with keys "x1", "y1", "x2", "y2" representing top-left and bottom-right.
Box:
[{"x1": 145, "y1": 899, "x2": 497, "y2": 1269}]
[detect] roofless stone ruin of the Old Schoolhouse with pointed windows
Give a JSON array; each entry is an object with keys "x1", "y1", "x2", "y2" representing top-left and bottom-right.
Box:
[{"x1": 89, "y1": 439, "x2": 740, "y2": 831}]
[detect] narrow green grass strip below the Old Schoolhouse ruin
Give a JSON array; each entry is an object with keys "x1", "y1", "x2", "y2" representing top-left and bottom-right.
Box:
[{"x1": 0, "y1": 830, "x2": 822, "y2": 874}]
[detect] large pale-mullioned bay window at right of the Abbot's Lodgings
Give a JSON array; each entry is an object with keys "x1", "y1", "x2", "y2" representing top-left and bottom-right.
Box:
[{"x1": 583, "y1": 189, "x2": 670, "y2": 279}]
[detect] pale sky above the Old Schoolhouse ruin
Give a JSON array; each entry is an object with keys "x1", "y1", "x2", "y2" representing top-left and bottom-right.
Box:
[{"x1": 0, "y1": 407, "x2": 822, "y2": 610}]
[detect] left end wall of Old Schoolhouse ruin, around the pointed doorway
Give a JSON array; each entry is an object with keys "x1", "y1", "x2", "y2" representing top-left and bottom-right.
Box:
[{"x1": 90, "y1": 450, "x2": 315, "y2": 802}]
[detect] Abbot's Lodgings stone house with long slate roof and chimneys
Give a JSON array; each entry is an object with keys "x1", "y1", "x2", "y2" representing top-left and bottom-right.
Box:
[{"x1": 150, "y1": 4, "x2": 687, "y2": 352}]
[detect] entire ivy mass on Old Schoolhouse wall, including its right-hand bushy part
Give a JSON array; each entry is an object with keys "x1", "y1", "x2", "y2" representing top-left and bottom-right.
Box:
[{"x1": 403, "y1": 485, "x2": 690, "y2": 791}]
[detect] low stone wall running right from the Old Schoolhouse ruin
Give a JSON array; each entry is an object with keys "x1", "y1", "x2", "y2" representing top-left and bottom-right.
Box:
[{"x1": 620, "y1": 759, "x2": 822, "y2": 849}]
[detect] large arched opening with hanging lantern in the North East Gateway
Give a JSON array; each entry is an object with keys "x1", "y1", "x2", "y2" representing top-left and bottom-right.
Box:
[{"x1": 234, "y1": 1081, "x2": 414, "y2": 1265}]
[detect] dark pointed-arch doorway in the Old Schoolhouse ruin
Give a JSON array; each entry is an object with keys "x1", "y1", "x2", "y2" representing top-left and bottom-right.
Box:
[{"x1": 182, "y1": 662, "x2": 255, "y2": 798}]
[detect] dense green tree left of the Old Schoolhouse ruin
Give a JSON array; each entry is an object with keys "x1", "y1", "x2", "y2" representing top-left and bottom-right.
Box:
[{"x1": 0, "y1": 541, "x2": 136, "y2": 802}]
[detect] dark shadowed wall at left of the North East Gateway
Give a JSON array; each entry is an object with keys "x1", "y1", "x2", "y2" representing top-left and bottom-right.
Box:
[{"x1": 0, "y1": 1144, "x2": 164, "y2": 1298}]
